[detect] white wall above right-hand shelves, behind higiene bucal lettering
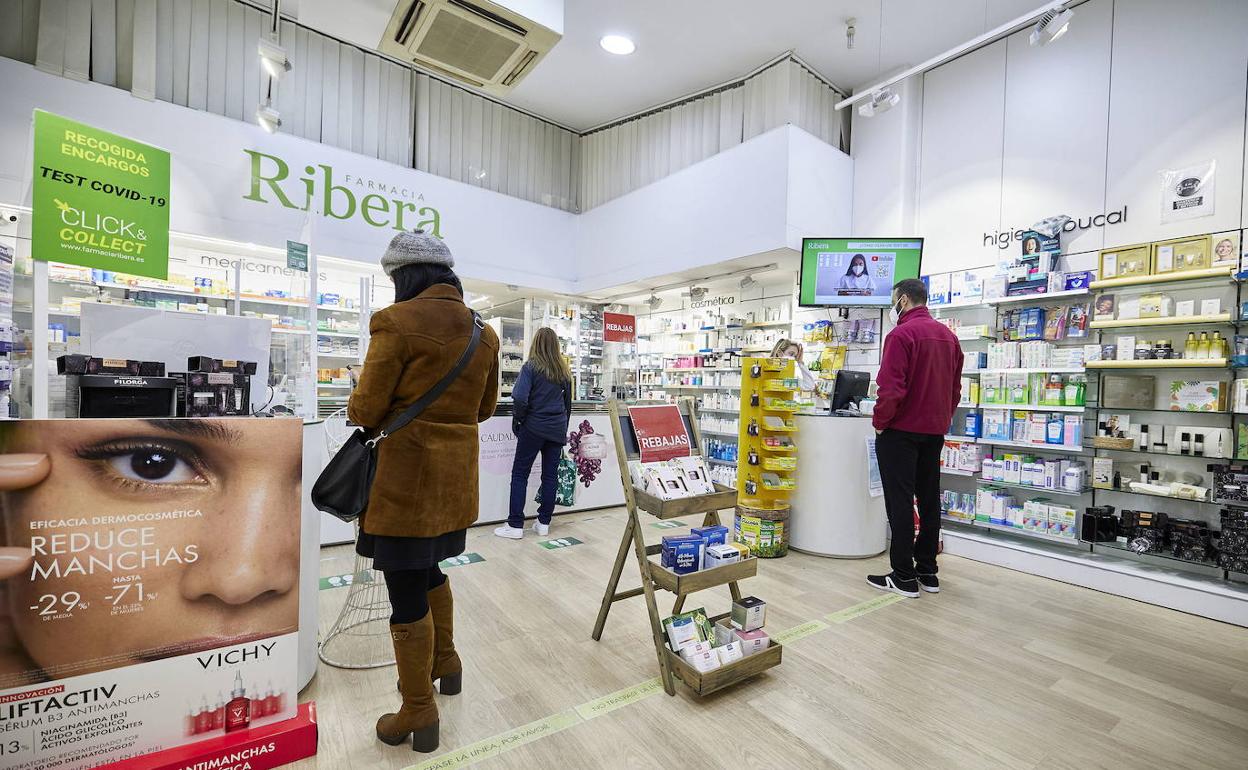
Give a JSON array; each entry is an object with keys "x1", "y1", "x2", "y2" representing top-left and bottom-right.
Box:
[{"x1": 852, "y1": 0, "x2": 1248, "y2": 272}]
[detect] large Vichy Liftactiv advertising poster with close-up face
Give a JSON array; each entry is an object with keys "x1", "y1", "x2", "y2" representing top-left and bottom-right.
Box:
[{"x1": 0, "y1": 418, "x2": 302, "y2": 770}]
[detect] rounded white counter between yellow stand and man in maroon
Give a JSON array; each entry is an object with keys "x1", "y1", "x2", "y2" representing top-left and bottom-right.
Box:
[{"x1": 789, "y1": 414, "x2": 889, "y2": 558}]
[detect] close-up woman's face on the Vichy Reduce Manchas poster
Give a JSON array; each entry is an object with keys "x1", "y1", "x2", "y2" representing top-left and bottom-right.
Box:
[{"x1": 0, "y1": 418, "x2": 302, "y2": 675}]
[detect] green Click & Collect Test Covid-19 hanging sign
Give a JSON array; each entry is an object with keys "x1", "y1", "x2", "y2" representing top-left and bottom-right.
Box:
[{"x1": 31, "y1": 110, "x2": 168, "y2": 280}]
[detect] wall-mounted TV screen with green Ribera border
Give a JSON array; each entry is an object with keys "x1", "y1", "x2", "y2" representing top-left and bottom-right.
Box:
[{"x1": 797, "y1": 238, "x2": 924, "y2": 307}]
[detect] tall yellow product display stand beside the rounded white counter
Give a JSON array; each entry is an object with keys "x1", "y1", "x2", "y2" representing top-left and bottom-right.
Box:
[{"x1": 734, "y1": 358, "x2": 800, "y2": 558}]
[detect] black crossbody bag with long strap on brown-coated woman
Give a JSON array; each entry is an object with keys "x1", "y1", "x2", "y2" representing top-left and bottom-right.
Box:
[{"x1": 312, "y1": 311, "x2": 485, "y2": 522}]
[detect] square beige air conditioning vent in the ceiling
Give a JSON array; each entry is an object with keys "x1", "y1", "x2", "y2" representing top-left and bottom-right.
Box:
[{"x1": 379, "y1": 0, "x2": 560, "y2": 94}]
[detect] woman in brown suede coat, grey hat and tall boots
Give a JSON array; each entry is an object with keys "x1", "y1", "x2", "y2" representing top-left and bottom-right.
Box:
[{"x1": 347, "y1": 230, "x2": 498, "y2": 751}]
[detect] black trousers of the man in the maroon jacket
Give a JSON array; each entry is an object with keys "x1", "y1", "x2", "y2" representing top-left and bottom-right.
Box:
[{"x1": 875, "y1": 429, "x2": 945, "y2": 580}]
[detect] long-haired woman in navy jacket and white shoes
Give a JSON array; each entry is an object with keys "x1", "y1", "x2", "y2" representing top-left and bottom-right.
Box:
[{"x1": 494, "y1": 327, "x2": 572, "y2": 540}]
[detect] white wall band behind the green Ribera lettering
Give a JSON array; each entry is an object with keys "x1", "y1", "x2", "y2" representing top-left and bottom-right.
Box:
[{"x1": 0, "y1": 59, "x2": 575, "y2": 292}]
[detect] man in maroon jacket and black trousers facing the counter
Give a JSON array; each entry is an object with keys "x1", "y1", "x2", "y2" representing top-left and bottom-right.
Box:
[{"x1": 866, "y1": 278, "x2": 962, "y2": 598}]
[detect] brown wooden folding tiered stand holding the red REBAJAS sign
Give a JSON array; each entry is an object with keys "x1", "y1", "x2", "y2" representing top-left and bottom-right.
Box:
[{"x1": 593, "y1": 398, "x2": 784, "y2": 695}]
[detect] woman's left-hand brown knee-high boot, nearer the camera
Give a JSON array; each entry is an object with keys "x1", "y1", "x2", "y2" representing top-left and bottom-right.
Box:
[{"x1": 377, "y1": 613, "x2": 438, "y2": 753}]
